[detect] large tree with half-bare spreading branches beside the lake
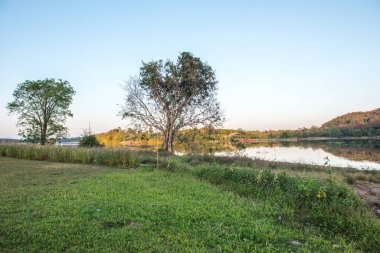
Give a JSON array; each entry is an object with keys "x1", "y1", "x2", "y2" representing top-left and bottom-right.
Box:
[{"x1": 122, "y1": 52, "x2": 223, "y2": 151}]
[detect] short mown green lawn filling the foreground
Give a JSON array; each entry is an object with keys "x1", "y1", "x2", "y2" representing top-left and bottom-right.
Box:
[{"x1": 0, "y1": 157, "x2": 380, "y2": 252}]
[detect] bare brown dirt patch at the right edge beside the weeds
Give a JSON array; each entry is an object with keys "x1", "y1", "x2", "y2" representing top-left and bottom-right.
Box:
[{"x1": 355, "y1": 181, "x2": 380, "y2": 220}]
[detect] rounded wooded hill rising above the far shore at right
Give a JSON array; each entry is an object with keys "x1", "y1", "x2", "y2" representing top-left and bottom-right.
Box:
[{"x1": 322, "y1": 108, "x2": 380, "y2": 128}]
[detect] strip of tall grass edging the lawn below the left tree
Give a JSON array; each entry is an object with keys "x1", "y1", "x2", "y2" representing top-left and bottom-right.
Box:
[{"x1": 0, "y1": 144, "x2": 140, "y2": 168}]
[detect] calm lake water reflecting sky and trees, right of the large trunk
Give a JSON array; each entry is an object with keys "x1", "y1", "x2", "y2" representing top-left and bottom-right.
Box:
[{"x1": 176, "y1": 140, "x2": 380, "y2": 170}]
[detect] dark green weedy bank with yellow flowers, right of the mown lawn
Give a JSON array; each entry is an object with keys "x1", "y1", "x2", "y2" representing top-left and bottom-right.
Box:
[{"x1": 193, "y1": 165, "x2": 380, "y2": 252}]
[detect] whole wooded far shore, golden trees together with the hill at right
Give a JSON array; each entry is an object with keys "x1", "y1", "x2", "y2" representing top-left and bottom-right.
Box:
[{"x1": 96, "y1": 109, "x2": 380, "y2": 148}]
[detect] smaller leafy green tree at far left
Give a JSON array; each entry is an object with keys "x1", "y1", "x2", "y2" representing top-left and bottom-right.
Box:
[{"x1": 7, "y1": 79, "x2": 75, "y2": 145}]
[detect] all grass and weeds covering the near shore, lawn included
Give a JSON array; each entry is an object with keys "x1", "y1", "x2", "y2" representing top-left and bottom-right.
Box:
[{"x1": 0, "y1": 144, "x2": 380, "y2": 252}]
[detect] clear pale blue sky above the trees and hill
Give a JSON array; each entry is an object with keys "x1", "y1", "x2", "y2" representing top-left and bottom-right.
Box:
[{"x1": 0, "y1": 0, "x2": 380, "y2": 138}]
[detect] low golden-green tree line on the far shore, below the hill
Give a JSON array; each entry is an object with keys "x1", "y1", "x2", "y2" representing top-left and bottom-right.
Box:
[{"x1": 96, "y1": 123, "x2": 380, "y2": 146}]
